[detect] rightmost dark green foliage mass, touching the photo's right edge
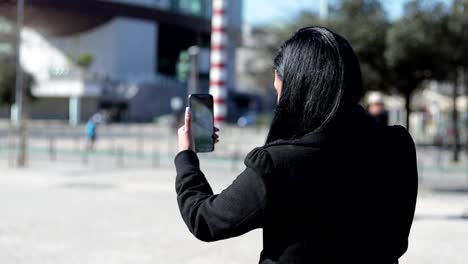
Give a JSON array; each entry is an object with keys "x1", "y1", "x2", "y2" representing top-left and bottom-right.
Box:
[{"x1": 385, "y1": 0, "x2": 468, "y2": 96}]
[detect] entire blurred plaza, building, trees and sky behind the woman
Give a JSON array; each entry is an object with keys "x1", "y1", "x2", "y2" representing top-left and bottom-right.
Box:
[{"x1": 0, "y1": 0, "x2": 468, "y2": 264}]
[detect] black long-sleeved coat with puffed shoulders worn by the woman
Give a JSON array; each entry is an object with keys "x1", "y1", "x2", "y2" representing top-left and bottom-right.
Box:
[{"x1": 175, "y1": 106, "x2": 418, "y2": 264}]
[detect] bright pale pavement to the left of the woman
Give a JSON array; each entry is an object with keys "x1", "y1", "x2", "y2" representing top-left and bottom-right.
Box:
[{"x1": 0, "y1": 165, "x2": 261, "y2": 264}]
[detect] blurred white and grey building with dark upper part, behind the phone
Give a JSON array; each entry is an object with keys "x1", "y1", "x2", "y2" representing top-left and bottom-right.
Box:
[{"x1": 0, "y1": 0, "x2": 242, "y2": 122}]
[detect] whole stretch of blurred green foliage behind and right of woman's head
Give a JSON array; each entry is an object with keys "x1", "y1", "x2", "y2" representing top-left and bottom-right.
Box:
[{"x1": 265, "y1": 0, "x2": 468, "y2": 100}]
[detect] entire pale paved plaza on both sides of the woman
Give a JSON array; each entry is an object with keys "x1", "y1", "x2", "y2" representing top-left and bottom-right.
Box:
[{"x1": 0, "y1": 124, "x2": 468, "y2": 264}]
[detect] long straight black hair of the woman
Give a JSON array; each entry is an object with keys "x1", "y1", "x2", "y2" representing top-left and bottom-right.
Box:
[{"x1": 267, "y1": 27, "x2": 362, "y2": 143}]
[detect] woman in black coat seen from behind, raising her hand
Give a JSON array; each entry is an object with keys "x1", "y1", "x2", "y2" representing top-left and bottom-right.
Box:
[{"x1": 175, "y1": 27, "x2": 417, "y2": 264}]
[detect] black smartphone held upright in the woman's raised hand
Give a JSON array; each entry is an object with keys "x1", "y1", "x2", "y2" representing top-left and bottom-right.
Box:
[{"x1": 189, "y1": 94, "x2": 214, "y2": 152}]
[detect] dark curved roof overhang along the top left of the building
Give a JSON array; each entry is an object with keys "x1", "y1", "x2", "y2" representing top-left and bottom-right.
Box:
[{"x1": 0, "y1": 0, "x2": 211, "y2": 36}]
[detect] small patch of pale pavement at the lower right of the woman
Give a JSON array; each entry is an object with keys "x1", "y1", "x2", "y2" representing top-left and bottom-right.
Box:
[{"x1": 400, "y1": 192, "x2": 468, "y2": 264}]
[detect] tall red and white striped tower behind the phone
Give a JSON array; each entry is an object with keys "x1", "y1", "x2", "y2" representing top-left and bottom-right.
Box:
[{"x1": 210, "y1": 0, "x2": 228, "y2": 126}]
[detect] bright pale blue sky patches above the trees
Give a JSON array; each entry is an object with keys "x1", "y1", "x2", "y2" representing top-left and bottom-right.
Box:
[{"x1": 243, "y1": 0, "x2": 451, "y2": 24}]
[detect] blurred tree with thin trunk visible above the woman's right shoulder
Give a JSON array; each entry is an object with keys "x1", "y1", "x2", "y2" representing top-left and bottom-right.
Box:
[{"x1": 385, "y1": 0, "x2": 447, "y2": 129}]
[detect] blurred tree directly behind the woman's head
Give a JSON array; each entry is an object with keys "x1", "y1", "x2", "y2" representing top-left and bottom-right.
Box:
[{"x1": 257, "y1": 0, "x2": 389, "y2": 95}]
